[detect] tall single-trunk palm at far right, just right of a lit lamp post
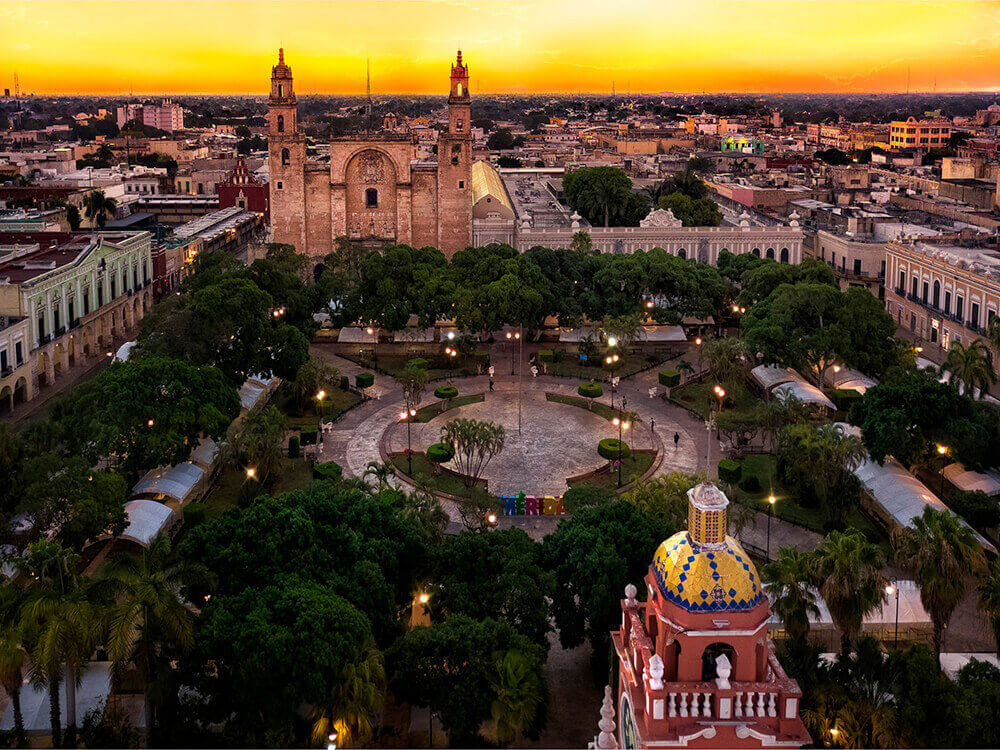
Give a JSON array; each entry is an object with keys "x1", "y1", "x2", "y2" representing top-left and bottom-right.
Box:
[{"x1": 893, "y1": 506, "x2": 986, "y2": 663}]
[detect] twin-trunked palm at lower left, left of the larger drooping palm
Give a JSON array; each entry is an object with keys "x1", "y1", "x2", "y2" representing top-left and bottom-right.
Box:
[{"x1": 19, "y1": 539, "x2": 99, "y2": 747}]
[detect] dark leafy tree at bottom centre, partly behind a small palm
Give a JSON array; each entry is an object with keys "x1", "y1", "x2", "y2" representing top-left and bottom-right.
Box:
[{"x1": 386, "y1": 614, "x2": 548, "y2": 747}]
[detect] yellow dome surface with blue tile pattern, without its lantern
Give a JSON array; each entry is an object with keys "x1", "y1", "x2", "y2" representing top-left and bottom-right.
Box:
[{"x1": 651, "y1": 531, "x2": 764, "y2": 612}]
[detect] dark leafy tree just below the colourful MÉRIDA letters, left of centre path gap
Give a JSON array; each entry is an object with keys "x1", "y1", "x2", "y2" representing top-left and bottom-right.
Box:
[{"x1": 430, "y1": 529, "x2": 554, "y2": 648}]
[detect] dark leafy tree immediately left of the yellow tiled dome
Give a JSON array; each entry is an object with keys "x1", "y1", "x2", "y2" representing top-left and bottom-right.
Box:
[{"x1": 542, "y1": 501, "x2": 678, "y2": 660}]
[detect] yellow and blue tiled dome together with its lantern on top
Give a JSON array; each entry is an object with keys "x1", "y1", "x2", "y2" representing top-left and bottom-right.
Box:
[{"x1": 650, "y1": 482, "x2": 764, "y2": 612}]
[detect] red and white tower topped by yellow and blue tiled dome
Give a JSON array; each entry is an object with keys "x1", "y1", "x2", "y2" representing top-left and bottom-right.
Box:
[{"x1": 612, "y1": 482, "x2": 810, "y2": 748}]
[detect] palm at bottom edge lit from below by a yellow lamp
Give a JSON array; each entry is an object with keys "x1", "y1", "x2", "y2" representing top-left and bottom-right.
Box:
[{"x1": 312, "y1": 638, "x2": 386, "y2": 747}]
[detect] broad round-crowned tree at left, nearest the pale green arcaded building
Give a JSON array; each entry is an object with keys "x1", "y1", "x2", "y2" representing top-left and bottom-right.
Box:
[{"x1": 61, "y1": 355, "x2": 240, "y2": 481}]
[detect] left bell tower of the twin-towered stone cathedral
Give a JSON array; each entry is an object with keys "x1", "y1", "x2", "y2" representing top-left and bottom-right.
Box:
[{"x1": 267, "y1": 49, "x2": 307, "y2": 252}]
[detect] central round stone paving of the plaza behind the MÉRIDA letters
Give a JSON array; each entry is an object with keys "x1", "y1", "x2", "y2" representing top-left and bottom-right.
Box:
[{"x1": 385, "y1": 388, "x2": 658, "y2": 495}]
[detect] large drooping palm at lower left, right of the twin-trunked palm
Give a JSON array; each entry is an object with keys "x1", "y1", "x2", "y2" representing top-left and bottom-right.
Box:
[{"x1": 95, "y1": 534, "x2": 194, "y2": 733}]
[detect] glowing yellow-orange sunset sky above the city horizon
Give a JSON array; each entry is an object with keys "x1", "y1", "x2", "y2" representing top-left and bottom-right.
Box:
[{"x1": 0, "y1": 0, "x2": 1000, "y2": 94}]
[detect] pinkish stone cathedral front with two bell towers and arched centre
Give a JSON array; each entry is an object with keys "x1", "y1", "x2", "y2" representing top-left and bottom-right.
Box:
[{"x1": 267, "y1": 50, "x2": 473, "y2": 258}]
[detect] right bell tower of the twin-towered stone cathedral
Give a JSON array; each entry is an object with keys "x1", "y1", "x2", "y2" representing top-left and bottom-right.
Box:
[{"x1": 437, "y1": 50, "x2": 472, "y2": 258}]
